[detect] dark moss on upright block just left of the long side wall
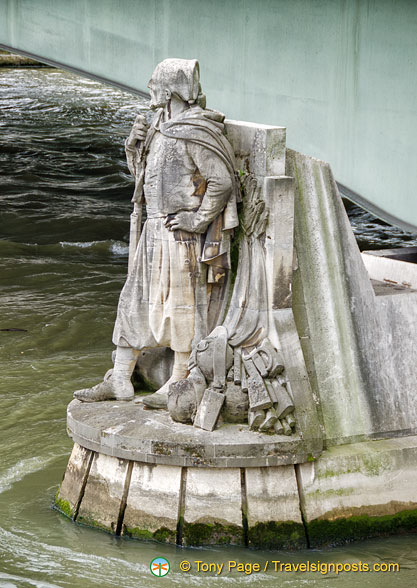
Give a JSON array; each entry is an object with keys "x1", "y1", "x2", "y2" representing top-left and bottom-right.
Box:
[{"x1": 248, "y1": 521, "x2": 307, "y2": 549}]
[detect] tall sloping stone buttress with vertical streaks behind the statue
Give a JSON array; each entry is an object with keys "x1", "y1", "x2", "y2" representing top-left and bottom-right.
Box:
[{"x1": 287, "y1": 150, "x2": 417, "y2": 445}]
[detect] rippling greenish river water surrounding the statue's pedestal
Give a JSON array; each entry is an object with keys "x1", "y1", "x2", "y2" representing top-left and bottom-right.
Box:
[{"x1": 0, "y1": 68, "x2": 417, "y2": 588}]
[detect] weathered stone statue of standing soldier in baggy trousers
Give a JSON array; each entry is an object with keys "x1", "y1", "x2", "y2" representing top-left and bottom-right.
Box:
[{"x1": 74, "y1": 59, "x2": 239, "y2": 408}]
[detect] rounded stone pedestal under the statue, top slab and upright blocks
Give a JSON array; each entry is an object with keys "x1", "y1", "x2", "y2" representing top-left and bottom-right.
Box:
[{"x1": 55, "y1": 400, "x2": 322, "y2": 548}]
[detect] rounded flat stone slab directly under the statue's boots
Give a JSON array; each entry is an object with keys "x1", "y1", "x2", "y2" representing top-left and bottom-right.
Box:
[{"x1": 67, "y1": 400, "x2": 322, "y2": 468}]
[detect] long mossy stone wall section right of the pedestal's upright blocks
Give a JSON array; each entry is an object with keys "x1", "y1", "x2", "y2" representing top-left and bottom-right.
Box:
[{"x1": 297, "y1": 436, "x2": 417, "y2": 545}]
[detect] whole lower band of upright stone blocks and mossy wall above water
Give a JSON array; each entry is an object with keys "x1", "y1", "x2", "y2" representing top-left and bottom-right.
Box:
[{"x1": 55, "y1": 436, "x2": 417, "y2": 549}]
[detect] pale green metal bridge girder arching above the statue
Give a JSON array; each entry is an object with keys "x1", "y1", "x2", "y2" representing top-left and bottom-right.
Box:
[{"x1": 0, "y1": 0, "x2": 417, "y2": 232}]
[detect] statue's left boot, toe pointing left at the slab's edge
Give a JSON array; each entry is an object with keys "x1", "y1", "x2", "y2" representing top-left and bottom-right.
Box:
[{"x1": 74, "y1": 347, "x2": 139, "y2": 402}]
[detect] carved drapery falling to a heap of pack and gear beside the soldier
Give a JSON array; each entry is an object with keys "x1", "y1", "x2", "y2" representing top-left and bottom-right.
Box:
[{"x1": 168, "y1": 172, "x2": 296, "y2": 435}]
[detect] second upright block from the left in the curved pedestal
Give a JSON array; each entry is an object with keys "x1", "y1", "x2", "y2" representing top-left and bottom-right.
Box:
[{"x1": 77, "y1": 453, "x2": 128, "y2": 533}]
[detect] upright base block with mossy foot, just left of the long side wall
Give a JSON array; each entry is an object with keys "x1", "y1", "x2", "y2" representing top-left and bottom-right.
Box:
[{"x1": 245, "y1": 466, "x2": 306, "y2": 549}]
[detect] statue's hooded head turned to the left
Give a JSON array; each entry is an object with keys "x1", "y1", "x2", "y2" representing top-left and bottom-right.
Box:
[{"x1": 148, "y1": 59, "x2": 201, "y2": 110}]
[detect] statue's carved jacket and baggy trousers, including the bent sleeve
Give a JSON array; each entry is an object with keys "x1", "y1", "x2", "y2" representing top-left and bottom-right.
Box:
[{"x1": 113, "y1": 131, "x2": 232, "y2": 352}]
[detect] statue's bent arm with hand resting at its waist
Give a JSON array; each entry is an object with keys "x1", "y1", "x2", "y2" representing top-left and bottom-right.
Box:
[{"x1": 165, "y1": 142, "x2": 233, "y2": 233}]
